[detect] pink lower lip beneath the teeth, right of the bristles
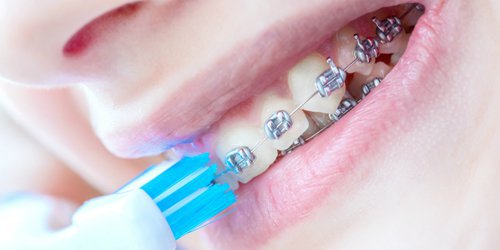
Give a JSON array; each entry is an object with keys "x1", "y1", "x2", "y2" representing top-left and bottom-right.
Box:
[{"x1": 208, "y1": 1, "x2": 443, "y2": 249}]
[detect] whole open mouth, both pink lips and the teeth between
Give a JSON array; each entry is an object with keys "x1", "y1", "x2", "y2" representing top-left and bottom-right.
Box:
[{"x1": 68, "y1": 0, "x2": 444, "y2": 249}]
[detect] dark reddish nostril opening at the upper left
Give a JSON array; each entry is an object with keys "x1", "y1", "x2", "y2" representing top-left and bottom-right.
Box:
[{"x1": 63, "y1": 2, "x2": 143, "y2": 57}]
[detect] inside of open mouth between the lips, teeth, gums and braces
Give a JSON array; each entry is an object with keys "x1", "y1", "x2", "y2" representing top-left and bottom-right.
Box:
[{"x1": 208, "y1": 4, "x2": 424, "y2": 183}]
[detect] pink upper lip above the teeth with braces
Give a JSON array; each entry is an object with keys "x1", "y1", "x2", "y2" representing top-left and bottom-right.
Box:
[{"x1": 96, "y1": 0, "x2": 408, "y2": 158}]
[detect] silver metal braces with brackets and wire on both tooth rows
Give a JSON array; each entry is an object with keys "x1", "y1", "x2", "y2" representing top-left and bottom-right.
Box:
[{"x1": 224, "y1": 4, "x2": 425, "y2": 174}]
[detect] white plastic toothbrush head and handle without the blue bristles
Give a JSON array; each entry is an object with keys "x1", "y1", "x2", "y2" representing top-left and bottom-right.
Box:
[{"x1": 1, "y1": 189, "x2": 176, "y2": 250}]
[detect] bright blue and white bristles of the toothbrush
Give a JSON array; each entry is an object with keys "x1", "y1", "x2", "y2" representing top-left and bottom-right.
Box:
[{"x1": 141, "y1": 154, "x2": 236, "y2": 239}]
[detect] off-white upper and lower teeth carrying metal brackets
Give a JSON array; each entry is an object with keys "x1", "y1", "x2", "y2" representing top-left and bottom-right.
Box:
[{"x1": 214, "y1": 3, "x2": 421, "y2": 185}]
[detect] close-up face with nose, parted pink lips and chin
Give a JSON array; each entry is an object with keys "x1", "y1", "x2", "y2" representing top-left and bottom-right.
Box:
[{"x1": 0, "y1": 0, "x2": 500, "y2": 249}]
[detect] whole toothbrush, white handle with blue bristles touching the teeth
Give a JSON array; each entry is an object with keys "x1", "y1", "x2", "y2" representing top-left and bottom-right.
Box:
[{"x1": 20, "y1": 154, "x2": 236, "y2": 250}]
